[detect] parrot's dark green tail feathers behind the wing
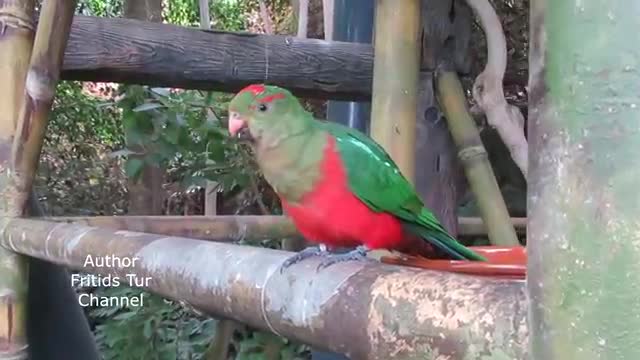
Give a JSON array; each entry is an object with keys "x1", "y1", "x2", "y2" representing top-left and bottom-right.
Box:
[{"x1": 406, "y1": 209, "x2": 487, "y2": 261}]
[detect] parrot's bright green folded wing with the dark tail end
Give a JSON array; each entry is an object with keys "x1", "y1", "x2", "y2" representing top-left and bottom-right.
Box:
[{"x1": 315, "y1": 120, "x2": 486, "y2": 261}]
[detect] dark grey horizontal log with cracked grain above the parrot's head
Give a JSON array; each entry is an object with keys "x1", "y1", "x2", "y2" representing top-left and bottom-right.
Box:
[{"x1": 62, "y1": 16, "x2": 373, "y2": 100}]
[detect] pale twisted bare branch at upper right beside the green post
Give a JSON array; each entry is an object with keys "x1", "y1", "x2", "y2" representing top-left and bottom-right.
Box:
[{"x1": 467, "y1": 0, "x2": 528, "y2": 179}]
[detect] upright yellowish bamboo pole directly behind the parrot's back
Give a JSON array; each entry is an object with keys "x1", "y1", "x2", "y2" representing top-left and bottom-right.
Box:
[{"x1": 370, "y1": 0, "x2": 421, "y2": 183}]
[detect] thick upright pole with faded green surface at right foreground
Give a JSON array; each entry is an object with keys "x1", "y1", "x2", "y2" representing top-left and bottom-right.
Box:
[{"x1": 527, "y1": 0, "x2": 640, "y2": 360}]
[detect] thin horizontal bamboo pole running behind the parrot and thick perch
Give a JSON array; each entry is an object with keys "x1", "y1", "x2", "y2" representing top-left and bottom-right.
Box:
[{"x1": 45, "y1": 215, "x2": 527, "y2": 242}]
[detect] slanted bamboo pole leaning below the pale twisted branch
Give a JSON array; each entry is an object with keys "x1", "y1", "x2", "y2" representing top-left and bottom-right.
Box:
[{"x1": 436, "y1": 69, "x2": 520, "y2": 246}]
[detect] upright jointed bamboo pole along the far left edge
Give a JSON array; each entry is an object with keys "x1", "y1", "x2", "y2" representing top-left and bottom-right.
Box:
[{"x1": 0, "y1": 0, "x2": 35, "y2": 359}]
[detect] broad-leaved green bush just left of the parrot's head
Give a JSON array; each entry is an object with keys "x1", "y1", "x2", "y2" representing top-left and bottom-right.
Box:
[{"x1": 117, "y1": 86, "x2": 256, "y2": 190}]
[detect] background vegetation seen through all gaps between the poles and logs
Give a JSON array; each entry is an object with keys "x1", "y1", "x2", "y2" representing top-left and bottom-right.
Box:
[{"x1": 36, "y1": 0, "x2": 528, "y2": 360}]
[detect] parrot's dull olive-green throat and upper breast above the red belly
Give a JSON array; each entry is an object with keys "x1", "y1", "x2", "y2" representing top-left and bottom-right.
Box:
[{"x1": 255, "y1": 126, "x2": 327, "y2": 204}]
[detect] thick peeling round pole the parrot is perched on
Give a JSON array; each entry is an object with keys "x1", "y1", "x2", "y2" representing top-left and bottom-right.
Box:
[{"x1": 0, "y1": 218, "x2": 528, "y2": 360}]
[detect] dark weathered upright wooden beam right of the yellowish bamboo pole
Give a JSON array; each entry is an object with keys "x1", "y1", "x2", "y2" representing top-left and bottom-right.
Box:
[{"x1": 415, "y1": 0, "x2": 472, "y2": 237}]
